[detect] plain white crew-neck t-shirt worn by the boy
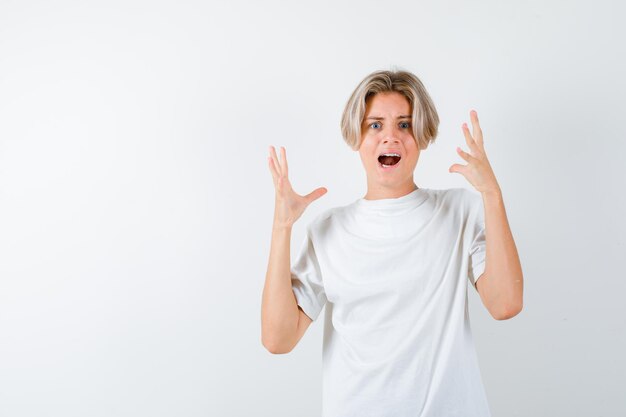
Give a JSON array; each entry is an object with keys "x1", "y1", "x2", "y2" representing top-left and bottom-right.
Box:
[{"x1": 291, "y1": 188, "x2": 491, "y2": 417}]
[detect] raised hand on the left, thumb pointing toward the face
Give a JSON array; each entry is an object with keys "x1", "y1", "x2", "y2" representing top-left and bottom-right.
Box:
[{"x1": 267, "y1": 146, "x2": 328, "y2": 227}]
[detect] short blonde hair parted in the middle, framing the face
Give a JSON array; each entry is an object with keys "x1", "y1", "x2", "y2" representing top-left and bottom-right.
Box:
[{"x1": 341, "y1": 71, "x2": 439, "y2": 151}]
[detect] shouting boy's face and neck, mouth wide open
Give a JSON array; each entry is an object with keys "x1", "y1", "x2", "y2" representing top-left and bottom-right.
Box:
[{"x1": 359, "y1": 91, "x2": 420, "y2": 193}]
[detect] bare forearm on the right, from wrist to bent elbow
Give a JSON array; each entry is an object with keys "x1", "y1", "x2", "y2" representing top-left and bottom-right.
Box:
[{"x1": 482, "y1": 190, "x2": 524, "y2": 317}]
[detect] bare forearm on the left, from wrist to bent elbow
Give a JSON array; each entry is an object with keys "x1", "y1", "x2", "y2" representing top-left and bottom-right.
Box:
[{"x1": 261, "y1": 224, "x2": 299, "y2": 352}]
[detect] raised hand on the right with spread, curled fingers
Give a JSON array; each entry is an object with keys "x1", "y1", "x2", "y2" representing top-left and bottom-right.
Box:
[{"x1": 448, "y1": 110, "x2": 500, "y2": 193}]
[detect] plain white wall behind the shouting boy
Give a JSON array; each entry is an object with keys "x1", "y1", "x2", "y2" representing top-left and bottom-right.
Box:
[{"x1": 0, "y1": 0, "x2": 626, "y2": 417}]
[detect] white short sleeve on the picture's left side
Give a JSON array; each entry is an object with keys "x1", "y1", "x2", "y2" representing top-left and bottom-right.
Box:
[{"x1": 291, "y1": 228, "x2": 327, "y2": 320}]
